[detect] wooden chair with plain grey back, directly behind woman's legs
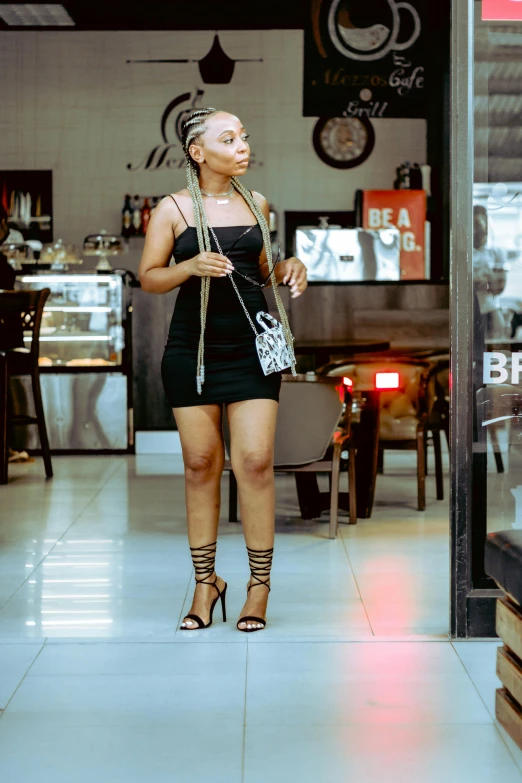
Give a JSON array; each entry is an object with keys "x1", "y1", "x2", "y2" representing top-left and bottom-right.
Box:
[{"x1": 224, "y1": 373, "x2": 357, "y2": 538}]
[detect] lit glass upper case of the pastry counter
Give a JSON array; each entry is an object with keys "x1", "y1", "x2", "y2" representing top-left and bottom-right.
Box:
[{"x1": 18, "y1": 274, "x2": 125, "y2": 367}]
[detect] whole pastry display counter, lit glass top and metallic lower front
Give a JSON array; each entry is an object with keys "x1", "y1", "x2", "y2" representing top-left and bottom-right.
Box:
[{"x1": 13, "y1": 272, "x2": 134, "y2": 452}]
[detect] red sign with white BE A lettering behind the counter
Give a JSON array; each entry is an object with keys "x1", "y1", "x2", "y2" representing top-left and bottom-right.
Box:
[{"x1": 363, "y1": 190, "x2": 426, "y2": 280}]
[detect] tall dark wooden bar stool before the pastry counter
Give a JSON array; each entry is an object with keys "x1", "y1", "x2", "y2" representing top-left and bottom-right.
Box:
[{"x1": 0, "y1": 288, "x2": 53, "y2": 484}]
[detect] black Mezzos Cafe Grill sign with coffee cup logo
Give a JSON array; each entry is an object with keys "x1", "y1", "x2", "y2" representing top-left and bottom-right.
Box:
[{"x1": 303, "y1": 0, "x2": 427, "y2": 117}]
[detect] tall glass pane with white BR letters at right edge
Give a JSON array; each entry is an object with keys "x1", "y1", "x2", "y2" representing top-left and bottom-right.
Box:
[{"x1": 472, "y1": 7, "x2": 522, "y2": 556}]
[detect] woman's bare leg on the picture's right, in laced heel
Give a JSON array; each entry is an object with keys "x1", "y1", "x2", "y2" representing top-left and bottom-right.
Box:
[{"x1": 227, "y1": 400, "x2": 278, "y2": 628}]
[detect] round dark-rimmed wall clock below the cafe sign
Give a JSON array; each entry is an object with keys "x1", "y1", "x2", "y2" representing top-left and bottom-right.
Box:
[{"x1": 313, "y1": 117, "x2": 375, "y2": 169}]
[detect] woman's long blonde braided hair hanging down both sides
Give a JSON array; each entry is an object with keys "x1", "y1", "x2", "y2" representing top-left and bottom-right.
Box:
[{"x1": 181, "y1": 108, "x2": 296, "y2": 394}]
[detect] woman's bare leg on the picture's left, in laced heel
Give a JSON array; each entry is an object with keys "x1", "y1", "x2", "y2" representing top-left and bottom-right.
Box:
[{"x1": 174, "y1": 405, "x2": 225, "y2": 628}]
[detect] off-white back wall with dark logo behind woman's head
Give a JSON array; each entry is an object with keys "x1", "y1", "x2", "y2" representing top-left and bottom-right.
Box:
[{"x1": 0, "y1": 30, "x2": 426, "y2": 242}]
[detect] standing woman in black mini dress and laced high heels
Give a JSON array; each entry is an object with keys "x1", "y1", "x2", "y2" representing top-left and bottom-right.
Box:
[{"x1": 139, "y1": 109, "x2": 307, "y2": 632}]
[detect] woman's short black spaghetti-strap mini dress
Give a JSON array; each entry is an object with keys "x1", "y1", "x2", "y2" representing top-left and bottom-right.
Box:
[{"x1": 161, "y1": 214, "x2": 281, "y2": 408}]
